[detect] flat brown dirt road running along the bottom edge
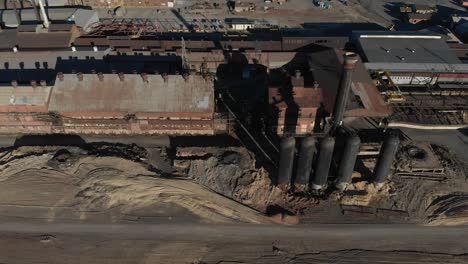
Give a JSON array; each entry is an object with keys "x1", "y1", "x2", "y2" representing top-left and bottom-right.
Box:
[{"x1": 0, "y1": 222, "x2": 468, "y2": 263}]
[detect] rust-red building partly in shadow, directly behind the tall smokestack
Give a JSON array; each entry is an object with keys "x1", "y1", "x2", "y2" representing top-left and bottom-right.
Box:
[{"x1": 268, "y1": 49, "x2": 392, "y2": 135}]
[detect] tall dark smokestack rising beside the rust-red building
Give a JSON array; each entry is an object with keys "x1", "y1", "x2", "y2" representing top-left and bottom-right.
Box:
[{"x1": 333, "y1": 52, "x2": 357, "y2": 127}]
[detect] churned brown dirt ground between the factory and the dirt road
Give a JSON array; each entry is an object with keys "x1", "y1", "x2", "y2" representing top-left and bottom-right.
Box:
[{"x1": 0, "y1": 134, "x2": 468, "y2": 225}]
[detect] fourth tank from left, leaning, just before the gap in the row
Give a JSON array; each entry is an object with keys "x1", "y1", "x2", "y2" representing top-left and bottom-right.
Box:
[{"x1": 336, "y1": 135, "x2": 361, "y2": 190}]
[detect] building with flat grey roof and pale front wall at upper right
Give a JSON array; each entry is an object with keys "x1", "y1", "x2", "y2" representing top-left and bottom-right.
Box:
[{"x1": 352, "y1": 32, "x2": 468, "y2": 86}]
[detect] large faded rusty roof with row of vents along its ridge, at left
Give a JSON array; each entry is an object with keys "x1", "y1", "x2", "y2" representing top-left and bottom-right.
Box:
[{"x1": 49, "y1": 74, "x2": 214, "y2": 113}]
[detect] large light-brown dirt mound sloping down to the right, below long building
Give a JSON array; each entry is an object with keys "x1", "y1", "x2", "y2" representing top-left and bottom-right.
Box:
[{"x1": 0, "y1": 146, "x2": 270, "y2": 223}]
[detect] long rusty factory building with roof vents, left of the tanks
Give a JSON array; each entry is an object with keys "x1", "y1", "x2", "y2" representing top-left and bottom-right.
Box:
[{"x1": 0, "y1": 73, "x2": 217, "y2": 135}]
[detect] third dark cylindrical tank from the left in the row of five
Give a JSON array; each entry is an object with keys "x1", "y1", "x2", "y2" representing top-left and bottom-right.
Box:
[{"x1": 312, "y1": 137, "x2": 335, "y2": 190}]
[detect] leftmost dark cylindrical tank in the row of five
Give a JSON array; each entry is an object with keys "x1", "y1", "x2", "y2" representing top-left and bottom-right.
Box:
[{"x1": 277, "y1": 137, "x2": 296, "y2": 185}]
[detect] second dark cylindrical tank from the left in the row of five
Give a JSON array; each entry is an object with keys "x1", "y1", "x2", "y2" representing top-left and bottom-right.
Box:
[{"x1": 295, "y1": 136, "x2": 317, "y2": 185}]
